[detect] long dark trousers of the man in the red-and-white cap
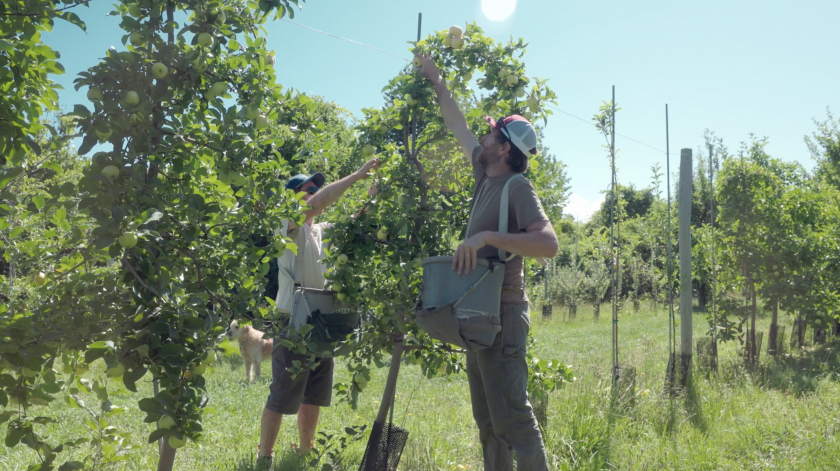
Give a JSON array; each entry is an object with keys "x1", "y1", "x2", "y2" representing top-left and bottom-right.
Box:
[{"x1": 467, "y1": 303, "x2": 548, "y2": 471}]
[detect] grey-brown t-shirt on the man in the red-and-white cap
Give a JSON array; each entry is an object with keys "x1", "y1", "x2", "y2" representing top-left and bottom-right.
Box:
[{"x1": 467, "y1": 146, "x2": 548, "y2": 304}]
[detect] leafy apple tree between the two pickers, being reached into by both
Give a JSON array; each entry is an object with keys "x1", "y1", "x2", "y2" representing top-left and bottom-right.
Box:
[{"x1": 308, "y1": 24, "x2": 562, "y2": 403}]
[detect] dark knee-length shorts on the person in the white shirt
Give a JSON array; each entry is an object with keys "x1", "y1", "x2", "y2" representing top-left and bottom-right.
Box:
[{"x1": 265, "y1": 342, "x2": 335, "y2": 415}]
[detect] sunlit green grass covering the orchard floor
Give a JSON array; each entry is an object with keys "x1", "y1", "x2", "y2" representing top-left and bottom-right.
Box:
[{"x1": 0, "y1": 303, "x2": 840, "y2": 471}]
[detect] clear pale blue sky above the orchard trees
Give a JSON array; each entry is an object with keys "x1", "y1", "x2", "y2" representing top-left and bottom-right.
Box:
[{"x1": 45, "y1": 0, "x2": 840, "y2": 218}]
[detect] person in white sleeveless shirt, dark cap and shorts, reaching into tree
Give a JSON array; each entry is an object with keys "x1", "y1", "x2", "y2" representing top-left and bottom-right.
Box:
[{"x1": 258, "y1": 159, "x2": 379, "y2": 467}]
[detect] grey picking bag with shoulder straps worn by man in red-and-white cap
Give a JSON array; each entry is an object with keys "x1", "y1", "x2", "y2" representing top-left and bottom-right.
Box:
[{"x1": 415, "y1": 173, "x2": 524, "y2": 351}]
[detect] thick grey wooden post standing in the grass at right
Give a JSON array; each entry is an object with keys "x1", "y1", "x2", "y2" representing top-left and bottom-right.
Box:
[{"x1": 678, "y1": 149, "x2": 694, "y2": 386}]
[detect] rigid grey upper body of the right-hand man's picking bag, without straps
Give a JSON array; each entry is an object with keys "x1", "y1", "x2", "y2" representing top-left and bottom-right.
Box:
[{"x1": 420, "y1": 256, "x2": 505, "y2": 318}]
